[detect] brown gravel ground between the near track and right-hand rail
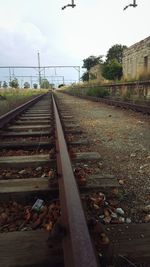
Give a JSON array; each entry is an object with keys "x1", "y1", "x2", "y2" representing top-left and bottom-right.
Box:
[{"x1": 58, "y1": 93, "x2": 150, "y2": 222}]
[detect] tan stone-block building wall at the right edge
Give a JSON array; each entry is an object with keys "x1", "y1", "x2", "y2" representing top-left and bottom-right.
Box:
[{"x1": 122, "y1": 36, "x2": 150, "y2": 80}]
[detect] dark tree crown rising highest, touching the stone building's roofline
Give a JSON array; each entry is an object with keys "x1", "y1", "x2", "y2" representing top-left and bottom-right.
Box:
[{"x1": 106, "y1": 44, "x2": 127, "y2": 64}]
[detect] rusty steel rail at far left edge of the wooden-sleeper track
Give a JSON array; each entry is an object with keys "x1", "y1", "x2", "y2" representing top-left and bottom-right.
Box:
[{"x1": 0, "y1": 94, "x2": 45, "y2": 128}]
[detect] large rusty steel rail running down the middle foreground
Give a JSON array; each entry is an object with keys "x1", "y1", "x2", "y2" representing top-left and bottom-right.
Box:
[{"x1": 52, "y1": 96, "x2": 100, "y2": 267}]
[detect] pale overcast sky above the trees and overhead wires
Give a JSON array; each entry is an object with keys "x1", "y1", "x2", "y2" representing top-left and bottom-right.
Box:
[{"x1": 0, "y1": 0, "x2": 150, "y2": 84}]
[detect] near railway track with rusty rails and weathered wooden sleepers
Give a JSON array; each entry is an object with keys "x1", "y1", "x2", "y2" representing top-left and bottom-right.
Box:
[{"x1": 0, "y1": 94, "x2": 150, "y2": 267}]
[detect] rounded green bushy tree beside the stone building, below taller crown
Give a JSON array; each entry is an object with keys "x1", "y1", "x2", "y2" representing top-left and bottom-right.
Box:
[{"x1": 102, "y1": 59, "x2": 122, "y2": 80}]
